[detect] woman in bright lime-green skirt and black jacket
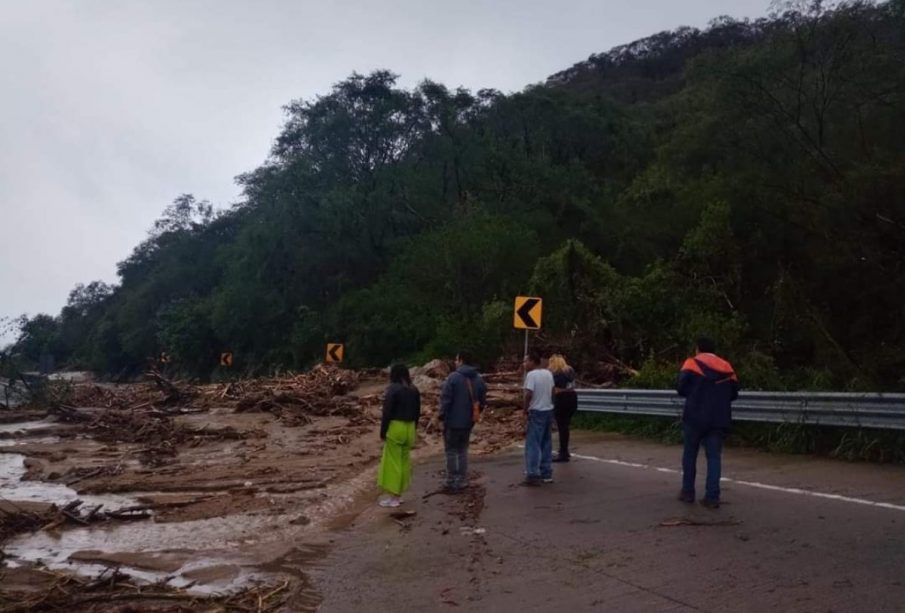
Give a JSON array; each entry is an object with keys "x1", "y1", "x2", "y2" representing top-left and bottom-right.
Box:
[{"x1": 377, "y1": 364, "x2": 421, "y2": 507}]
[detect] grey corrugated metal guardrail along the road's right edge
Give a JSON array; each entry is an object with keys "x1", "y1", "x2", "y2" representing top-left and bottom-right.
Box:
[{"x1": 578, "y1": 389, "x2": 905, "y2": 430}]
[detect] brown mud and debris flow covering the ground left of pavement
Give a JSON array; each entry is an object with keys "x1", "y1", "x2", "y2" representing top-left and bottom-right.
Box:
[{"x1": 0, "y1": 363, "x2": 521, "y2": 613}]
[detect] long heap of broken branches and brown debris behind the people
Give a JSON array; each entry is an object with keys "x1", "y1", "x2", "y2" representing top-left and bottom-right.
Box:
[{"x1": 24, "y1": 360, "x2": 524, "y2": 466}]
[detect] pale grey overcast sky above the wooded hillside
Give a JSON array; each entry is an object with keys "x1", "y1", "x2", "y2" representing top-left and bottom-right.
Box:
[{"x1": 0, "y1": 0, "x2": 770, "y2": 341}]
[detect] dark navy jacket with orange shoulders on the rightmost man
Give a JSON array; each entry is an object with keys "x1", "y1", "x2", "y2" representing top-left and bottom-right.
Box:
[{"x1": 677, "y1": 353, "x2": 738, "y2": 430}]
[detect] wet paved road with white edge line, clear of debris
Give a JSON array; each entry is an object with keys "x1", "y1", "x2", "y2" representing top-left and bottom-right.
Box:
[{"x1": 315, "y1": 433, "x2": 905, "y2": 612}]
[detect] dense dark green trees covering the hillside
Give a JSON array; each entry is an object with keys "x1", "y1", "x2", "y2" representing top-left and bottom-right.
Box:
[{"x1": 7, "y1": 0, "x2": 905, "y2": 389}]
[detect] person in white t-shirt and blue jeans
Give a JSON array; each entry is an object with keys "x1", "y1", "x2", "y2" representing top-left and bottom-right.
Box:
[{"x1": 524, "y1": 351, "x2": 553, "y2": 486}]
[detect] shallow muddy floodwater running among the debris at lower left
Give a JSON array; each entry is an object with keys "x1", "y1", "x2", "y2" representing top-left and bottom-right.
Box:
[{"x1": 0, "y1": 420, "x2": 374, "y2": 603}]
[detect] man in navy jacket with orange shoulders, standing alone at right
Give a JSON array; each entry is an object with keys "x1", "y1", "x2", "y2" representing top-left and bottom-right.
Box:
[{"x1": 677, "y1": 337, "x2": 739, "y2": 509}]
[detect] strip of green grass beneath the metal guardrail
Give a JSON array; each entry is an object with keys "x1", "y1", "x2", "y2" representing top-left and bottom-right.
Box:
[{"x1": 572, "y1": 413, "x2": 905, "y2": 464}]
